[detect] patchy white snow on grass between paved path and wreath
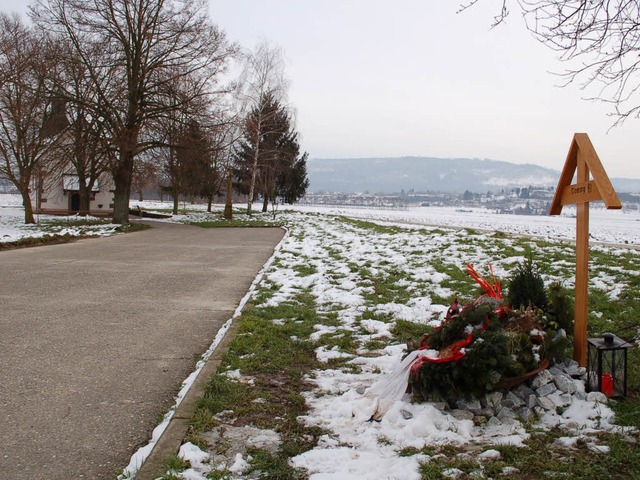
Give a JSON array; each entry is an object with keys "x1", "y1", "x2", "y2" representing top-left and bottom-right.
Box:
[{"x1": 168, "y1": 214, "x2": 632, "y2": 480}]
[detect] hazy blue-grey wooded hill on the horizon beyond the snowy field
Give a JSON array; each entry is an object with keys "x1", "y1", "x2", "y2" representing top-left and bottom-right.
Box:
[{"x1": 307, "y1": 157, "x2": 640, "y2": 193}]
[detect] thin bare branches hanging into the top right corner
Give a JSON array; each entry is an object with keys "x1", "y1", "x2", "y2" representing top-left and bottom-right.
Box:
[{"x1": 461, "y1": 0, "x2": 640, "y2": 124}]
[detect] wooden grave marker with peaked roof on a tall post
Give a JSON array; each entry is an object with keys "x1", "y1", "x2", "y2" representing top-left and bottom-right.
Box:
[{"x1": 549, "y1": 133, "x2": 622, "y2": 367}]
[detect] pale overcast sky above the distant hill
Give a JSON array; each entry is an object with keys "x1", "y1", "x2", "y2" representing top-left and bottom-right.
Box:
[{"x1": 5, "y1": 0, "x2": 640, "y2": 178}]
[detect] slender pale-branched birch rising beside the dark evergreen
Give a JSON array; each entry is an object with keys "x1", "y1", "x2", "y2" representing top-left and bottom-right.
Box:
[{"x1": 240, "y1": 41, "x2": 288, "y2": 215}]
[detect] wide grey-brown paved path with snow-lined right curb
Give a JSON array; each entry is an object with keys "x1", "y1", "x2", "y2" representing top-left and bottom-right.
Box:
[{"x1": 0, "y1": 223, "x2": 283, "y2": 480}]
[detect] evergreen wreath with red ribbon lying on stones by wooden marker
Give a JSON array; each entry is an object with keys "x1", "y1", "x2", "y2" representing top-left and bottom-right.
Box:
[{"x1": 409, "y1": 262, "x2": 566, "y2": 401}]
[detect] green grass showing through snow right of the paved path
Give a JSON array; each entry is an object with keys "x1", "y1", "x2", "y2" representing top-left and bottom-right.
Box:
[{"x1": 165, "y1": 213, "x2": 640, "y2": 479}]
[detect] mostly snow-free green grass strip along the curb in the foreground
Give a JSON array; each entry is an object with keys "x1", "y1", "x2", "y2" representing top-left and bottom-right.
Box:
[{"x1": 184, "y1": 293, "x2": 323, "y2": 479}]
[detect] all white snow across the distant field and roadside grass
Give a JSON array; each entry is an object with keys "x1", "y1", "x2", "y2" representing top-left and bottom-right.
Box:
[{"x1": 0, "y1": 195, "x2": 640, "y2": 480}]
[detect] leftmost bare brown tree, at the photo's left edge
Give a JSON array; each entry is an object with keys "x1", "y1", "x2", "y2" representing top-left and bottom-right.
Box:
[{"x1": 0, "y1": 13, "x2": 64, "y2": 223}]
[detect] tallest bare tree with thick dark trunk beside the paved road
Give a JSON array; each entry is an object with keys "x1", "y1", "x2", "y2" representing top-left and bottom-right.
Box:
[{"x1": 31, "y1": 0, "x2": 235, "y2": 223}]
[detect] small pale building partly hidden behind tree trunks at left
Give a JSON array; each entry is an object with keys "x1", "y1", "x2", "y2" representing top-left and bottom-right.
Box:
[{"x1": 31, "y1": 168, "x2": 115, "y2": 217}]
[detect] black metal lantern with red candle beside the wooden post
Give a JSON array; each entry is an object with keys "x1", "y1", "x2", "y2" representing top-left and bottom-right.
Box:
[{"x1": 587, "y1": 333, "x2": 629, "y2": 397}]
